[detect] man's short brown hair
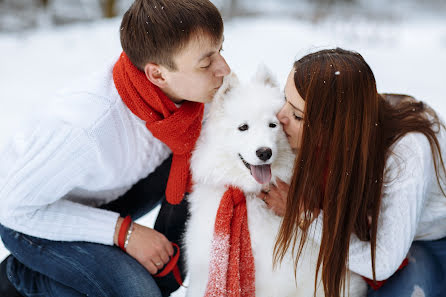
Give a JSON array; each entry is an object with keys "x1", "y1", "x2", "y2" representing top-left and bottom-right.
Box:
[{"x1": 120, "y1": 0, "x2": 223, "y2": 70}]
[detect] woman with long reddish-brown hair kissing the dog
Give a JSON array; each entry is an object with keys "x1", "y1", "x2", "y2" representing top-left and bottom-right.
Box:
[{"x1": 261, "y1": 48, "x2": 446, "y2": 297}]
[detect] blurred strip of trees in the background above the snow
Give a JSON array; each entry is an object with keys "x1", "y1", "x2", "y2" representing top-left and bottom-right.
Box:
[{"x1": 0, "y1": 0, "x2": 446, "y2": 32}]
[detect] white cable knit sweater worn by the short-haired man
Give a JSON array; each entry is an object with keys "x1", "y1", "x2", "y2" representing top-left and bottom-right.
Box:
[{"x1": 0, "y1": 61, "x2": 170, "y2": 245}]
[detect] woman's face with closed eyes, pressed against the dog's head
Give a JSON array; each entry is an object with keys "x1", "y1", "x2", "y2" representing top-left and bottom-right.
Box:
[{"x1": 277, "y1": 68, "x2": 305, "y2": 151}]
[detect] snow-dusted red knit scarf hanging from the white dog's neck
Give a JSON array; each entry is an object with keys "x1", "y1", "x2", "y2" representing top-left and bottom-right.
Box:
[{"x1": 205, "y1": 187, "x2": 255, "y2": 297}]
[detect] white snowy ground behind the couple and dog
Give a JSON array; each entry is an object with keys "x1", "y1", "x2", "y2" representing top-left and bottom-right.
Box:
[{"x1": 0, "y1": 10, "x2": 446, "y2": 296}]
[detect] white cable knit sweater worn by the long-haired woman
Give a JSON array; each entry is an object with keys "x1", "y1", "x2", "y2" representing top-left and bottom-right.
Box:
[{"x1": 310, "y1": 130, "x2": 446, "y2": 280}]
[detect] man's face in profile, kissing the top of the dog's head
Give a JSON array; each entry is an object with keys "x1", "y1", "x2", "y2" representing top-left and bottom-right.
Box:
[{"x1": 160, "y1": 34, "x2": 231, "y2": 103}]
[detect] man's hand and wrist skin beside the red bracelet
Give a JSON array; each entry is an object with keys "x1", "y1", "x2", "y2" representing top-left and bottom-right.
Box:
[{"x1": 115, "y1": 218, "x2": 174, "y2": 274}]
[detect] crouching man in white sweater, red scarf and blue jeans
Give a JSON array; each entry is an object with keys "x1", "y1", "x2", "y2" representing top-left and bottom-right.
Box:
[{"x1": 0, "y1": 0, "x2": 230, "y2": 297}]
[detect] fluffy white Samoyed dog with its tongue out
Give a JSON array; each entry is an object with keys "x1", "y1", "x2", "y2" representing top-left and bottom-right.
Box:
[{"x1": 184, "y1": 67, "x2": 366, "y2": 297}]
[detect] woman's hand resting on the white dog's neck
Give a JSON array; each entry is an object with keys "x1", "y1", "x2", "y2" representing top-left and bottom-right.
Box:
[{"x1": 258, "y1": 178, "x2": 290, "y2": 217}]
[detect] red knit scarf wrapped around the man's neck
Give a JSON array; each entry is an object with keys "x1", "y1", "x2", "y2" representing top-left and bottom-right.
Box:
[{"x1": 113, "y1": 52, "x2": 204, "y2": 204}]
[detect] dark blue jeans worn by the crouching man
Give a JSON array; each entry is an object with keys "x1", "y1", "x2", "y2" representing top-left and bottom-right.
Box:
[{"x1": 0, "y1": 158, "x2": 187, "y2": 297}]
